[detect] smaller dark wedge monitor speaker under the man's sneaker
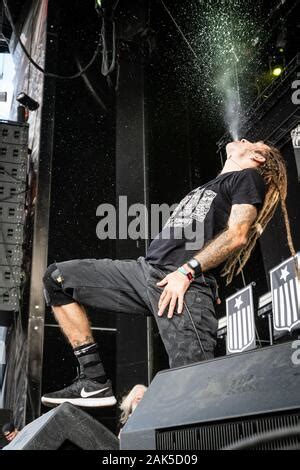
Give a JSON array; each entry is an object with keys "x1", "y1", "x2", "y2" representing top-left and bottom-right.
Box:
[{"x1": 3, "y1": 403, "x2": 119, "y2": 450}]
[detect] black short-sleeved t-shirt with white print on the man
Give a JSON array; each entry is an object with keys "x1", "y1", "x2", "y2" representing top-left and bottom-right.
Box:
[{"x1": 146, "y1": 168, "x2": 265, "y2": 275}]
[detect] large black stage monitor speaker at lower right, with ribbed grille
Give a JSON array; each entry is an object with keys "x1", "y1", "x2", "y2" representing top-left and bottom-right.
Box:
[{"x1": 120, "y1": 341, "x2": 300, "y2": 450}]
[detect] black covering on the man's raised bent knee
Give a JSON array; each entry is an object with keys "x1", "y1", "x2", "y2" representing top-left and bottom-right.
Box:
[{"x1": 43, "y1": 263, "x2": 74, "y2": 306}]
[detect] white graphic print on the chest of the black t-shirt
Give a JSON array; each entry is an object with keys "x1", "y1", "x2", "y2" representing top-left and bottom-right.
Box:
[{"x1": 164, "y1": 188, "x2": 217, "y2": 228}]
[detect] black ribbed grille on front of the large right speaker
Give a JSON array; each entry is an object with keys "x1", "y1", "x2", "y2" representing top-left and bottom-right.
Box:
[{"x1": 156, "y1": 413, "x2": 300, "y2": 450}]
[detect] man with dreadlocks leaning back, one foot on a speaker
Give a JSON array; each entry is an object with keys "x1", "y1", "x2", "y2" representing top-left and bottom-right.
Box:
[{"x1": 42, "y1": 139, "x2": 295, "y2": 406}]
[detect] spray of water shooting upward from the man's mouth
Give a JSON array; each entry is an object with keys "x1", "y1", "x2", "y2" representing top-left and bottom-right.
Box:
[{"x1": 171, "y1": 0, "x2": 266, "y2": 140}]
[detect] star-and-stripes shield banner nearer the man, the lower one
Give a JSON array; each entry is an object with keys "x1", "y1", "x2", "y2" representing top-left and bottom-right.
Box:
[{"x1": 226, "y1": 284, "x2": 256, "y2": 354}]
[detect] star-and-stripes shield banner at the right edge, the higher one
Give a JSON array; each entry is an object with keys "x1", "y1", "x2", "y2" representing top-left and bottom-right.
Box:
[{"x1": 270, "y1": 253, "x2": 300, "y2": 331}]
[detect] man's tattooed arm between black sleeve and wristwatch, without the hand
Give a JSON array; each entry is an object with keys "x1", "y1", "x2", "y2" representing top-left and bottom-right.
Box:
[{"x1": 195, "y1": 204, "x2": 257, "y2": 271}]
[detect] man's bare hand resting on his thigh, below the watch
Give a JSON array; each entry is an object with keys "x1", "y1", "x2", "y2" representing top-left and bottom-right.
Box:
[{"x1": 157, "y1": 271, "x2": 190, "y2": 318}]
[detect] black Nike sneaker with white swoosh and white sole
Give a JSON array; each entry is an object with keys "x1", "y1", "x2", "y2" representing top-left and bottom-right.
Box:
[{"x1": 42, "y1": 375, "x2": 117, "y2": 407}]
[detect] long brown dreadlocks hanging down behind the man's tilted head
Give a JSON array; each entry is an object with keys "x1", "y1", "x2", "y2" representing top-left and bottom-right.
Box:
[{"x1": 221, "y1": 144, "x2": 299, "y2": 285}]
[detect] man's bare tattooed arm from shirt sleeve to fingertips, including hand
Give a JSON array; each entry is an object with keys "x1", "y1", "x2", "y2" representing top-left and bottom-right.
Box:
[{"x1": 157, "y1": 204, "x2": 257, "y2": 318}]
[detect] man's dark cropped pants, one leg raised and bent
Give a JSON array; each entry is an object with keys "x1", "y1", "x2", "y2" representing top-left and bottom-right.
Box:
[{"x1": 44, "y1": 256, "x2": 218, "y2": 367}]
